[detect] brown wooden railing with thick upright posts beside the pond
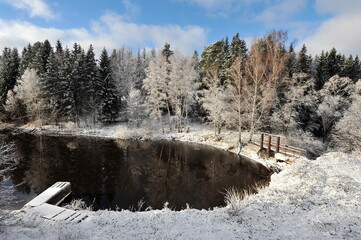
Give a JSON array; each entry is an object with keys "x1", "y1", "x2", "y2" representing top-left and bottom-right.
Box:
[{"x1": 252, "y1": 133, "x2": 307, "y2": 158}]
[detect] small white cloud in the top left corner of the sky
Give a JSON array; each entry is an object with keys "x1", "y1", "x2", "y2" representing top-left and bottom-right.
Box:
[{"x1": 1, "y1": 0, "x2": 55, "y2": 19}]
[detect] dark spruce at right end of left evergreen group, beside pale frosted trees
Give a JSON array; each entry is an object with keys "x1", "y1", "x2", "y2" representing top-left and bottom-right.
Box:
[{"x1": 99, "y1": 48, "x2": 120, "y2": 122}]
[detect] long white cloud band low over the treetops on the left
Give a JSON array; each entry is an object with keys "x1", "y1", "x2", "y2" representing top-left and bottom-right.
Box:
[{"x1": 0, "y1": 13, "x2": 206, "y2": 53}]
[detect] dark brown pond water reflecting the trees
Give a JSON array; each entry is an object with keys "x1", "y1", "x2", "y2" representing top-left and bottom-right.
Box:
[{"x1": 0, "y1": 135, "x2": 270, "y2": 210}]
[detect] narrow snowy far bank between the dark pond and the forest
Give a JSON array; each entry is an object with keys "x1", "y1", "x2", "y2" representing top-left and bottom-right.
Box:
[{"x1": 9, "y1": 123, "x2": 294, "y2": 169}]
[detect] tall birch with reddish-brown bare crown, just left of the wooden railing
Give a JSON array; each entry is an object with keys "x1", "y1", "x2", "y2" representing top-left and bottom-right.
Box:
[{"x1": 243, "y1": 32, "x2": 287, "y2": 140}]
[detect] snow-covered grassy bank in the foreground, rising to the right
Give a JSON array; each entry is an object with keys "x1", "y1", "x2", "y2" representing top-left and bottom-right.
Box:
[{"x1": 0, "y1": 153, "x2": 361, "y2": 239}]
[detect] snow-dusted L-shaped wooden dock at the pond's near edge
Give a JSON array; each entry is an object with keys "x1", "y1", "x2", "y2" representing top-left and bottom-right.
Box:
[{"x1": 21, "y1": 182, "x2": 88, "y2": 222}]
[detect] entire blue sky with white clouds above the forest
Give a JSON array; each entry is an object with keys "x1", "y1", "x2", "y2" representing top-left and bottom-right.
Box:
[{"x1": 0, "y1": 0, "x2": 361, "y2": 54}]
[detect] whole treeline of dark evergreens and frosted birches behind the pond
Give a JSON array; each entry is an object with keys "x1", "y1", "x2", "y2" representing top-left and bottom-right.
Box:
[{"x1": 0, "y1": 31, "x2": 361, "y2": 153}]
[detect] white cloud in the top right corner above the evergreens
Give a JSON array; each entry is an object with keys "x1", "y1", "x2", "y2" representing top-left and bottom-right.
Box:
[{"x1": 300, "y1": 0, "x2": 361, "y2": 55}]
